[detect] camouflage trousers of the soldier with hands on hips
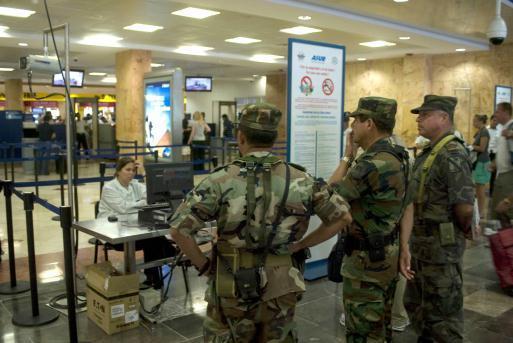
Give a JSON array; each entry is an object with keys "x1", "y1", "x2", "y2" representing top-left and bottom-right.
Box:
[{"x1": 203, "y1": 293, "x2": 297, "y2": 343}]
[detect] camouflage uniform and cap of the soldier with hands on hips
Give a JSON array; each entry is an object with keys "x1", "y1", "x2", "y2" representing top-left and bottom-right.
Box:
[{"x1": 171, "y1": 103, "x2": 348, "y2": 342}]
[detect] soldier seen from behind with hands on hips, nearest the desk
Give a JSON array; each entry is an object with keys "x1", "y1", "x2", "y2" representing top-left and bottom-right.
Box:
[{"x1": 171, "y1": 104, "x2": 351, "y2": 343}]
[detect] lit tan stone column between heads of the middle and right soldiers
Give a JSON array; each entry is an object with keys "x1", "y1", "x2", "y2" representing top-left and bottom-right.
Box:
[{"x1": 395, "y1": 55, "x2": 432, "y2": 146}]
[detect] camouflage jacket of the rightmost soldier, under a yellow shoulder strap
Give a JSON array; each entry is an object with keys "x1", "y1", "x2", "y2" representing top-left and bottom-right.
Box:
[{"x1": 410, "y1": 132, "x2": 475, "y2": 263}]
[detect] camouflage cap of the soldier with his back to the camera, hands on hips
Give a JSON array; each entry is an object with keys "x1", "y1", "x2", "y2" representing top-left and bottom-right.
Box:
[{"x1": 239, "y1": 103, "x2": 281, "y2": 132}]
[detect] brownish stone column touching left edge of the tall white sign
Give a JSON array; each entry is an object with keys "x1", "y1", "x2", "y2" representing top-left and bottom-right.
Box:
[{"x1": 265, "y1": 73, "x2": 287, "y2": 142}]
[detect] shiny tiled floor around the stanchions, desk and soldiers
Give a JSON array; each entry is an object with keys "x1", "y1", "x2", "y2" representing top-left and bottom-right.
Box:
[{"x1": 0, "y1": 163, "x2": 513, "y2": 343}]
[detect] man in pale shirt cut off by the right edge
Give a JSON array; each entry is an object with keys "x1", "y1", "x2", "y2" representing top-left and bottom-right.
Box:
[{"x1": 492, "y1": 102, "x2": 513, "y2": 224}]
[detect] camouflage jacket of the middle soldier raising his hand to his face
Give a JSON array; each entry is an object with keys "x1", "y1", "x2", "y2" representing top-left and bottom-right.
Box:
[{"x1": 335, "y1": 138, "x2": 409, "y2": 285}]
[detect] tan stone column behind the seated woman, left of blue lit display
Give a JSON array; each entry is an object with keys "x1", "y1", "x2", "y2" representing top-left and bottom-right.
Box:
[{"x1": 116, "y1": 50, "x2": 151, "y2": 160}]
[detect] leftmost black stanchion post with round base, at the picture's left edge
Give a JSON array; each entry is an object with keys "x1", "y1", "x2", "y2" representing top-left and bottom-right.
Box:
[{"x1": 0, "y1": 180, "x2": 30, "y2": 294}]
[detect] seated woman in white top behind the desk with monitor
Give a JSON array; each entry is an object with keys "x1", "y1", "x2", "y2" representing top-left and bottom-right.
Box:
[{"x1": 98, "y1": 157, "x2": 176, "y2": 289}]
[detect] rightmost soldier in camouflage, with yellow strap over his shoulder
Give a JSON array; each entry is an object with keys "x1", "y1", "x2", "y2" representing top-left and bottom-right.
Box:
[{"x1": 404, "y1": 95, "x2": 475, "y2": 343}]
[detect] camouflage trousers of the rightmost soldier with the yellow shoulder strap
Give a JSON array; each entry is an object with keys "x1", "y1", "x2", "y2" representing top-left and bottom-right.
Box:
[{"x1": 404, "y1": 258, "x2": 463, "y2": 343}]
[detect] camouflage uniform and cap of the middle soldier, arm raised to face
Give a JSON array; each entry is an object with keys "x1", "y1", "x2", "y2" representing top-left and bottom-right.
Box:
[{"x1": 334, "y1": 97, "x2": 409, "y2": 342}]
